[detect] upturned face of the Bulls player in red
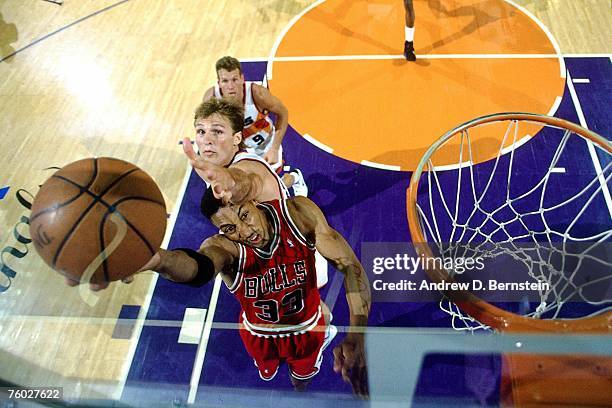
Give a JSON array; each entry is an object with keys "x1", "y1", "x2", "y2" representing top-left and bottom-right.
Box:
[{"x1": 211, "y1": 201, "x2": 270, "y2": 248}]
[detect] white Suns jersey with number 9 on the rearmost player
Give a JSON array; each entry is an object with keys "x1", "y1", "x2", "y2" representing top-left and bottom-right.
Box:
[{"x1": 215, "y1": 81, "x2": 275, "y2": 157}]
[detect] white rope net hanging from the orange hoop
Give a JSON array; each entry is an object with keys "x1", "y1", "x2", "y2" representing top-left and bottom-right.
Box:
[{"x1": 413, "y1": 114, "x2": 612, "y2": 330}]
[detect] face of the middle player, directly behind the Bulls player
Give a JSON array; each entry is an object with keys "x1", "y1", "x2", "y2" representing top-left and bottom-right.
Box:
[{"x1": 195, "y1": 113, "x2": 242, "y2": 166}]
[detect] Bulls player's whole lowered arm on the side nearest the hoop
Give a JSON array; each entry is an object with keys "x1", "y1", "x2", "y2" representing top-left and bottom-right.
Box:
[{"x1": 288, "y1": 197, "x2": 371, "y2": 397}]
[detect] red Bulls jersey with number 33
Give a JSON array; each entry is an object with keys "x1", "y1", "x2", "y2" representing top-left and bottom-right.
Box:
[{"x1": 228, "y1": 200, "x2": 321, "y2": 337}]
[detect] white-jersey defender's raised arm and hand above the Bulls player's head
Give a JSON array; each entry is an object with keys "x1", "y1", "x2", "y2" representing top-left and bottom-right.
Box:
[{"x1": 183, "y1": 138, "x2": 263, "y2": 204}]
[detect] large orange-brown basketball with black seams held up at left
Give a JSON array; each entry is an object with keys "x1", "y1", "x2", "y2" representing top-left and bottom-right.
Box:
[{"x1": 30, "y1": 157, "x2": 167, "y2": 283}]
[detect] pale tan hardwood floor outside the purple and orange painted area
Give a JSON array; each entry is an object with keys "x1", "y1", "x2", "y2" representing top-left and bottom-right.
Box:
[{"x1": 0, "y1": 0, "x2": 612, "y2": 397}]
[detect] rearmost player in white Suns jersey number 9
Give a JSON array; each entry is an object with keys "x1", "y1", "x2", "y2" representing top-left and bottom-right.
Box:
[{"x1": 203, "y1": 56, "x2": 308, "y2": 196}]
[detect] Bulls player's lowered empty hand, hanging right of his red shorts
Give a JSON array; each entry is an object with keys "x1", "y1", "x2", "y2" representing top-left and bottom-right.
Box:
[{"x1": 334, "y1": 333, "x2": 368, "y2": 398}]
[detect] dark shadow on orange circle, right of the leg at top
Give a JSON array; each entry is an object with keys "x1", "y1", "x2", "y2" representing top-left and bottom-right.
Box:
[{"x1": 424, "y1": 0, "x2": 511, "y2": 54}]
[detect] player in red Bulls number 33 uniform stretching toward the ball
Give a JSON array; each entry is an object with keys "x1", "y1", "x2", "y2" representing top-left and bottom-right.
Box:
[{"x1": 142, "y1": 187, "x2": 371, "y2": 397}]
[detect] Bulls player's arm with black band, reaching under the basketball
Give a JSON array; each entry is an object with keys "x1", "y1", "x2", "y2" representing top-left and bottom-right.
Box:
[{"x1": 140, "y1": 235, "x2": 238, "y2": 286}]
